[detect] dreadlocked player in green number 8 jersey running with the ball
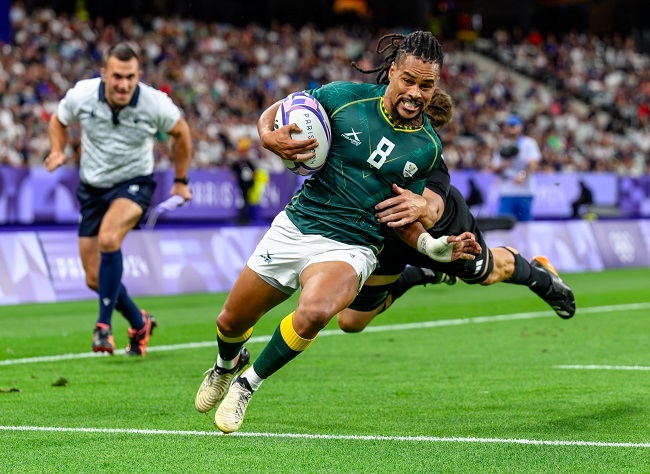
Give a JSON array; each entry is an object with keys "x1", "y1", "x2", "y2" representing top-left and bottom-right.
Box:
[{"x1": 195, "y1": 31, "x2": 480, "y2": 433}]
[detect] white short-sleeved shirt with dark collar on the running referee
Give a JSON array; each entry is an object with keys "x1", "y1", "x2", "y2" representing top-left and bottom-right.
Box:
[{"x1": 57, "y1": 78, "x2": 181, "y2": 188}]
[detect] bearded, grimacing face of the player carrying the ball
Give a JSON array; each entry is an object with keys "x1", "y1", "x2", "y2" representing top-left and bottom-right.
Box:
[{"x1": 384, "y1": 56, "x2": 440, "y2": 126}]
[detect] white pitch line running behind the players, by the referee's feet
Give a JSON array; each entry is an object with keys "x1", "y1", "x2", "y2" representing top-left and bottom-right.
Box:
[{"x1": 0, "y1": 302, "x2": 650, "y2": 366}]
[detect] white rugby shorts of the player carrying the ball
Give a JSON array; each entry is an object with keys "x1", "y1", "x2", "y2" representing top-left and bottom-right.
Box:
[{"x1": 247, "y1": 211, "x2": 377, "y2": 294}]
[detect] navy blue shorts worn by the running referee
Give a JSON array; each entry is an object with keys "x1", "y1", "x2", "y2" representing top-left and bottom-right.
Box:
[{"x1": 77, "y1": 175, "x2": 156, "y2": 237}]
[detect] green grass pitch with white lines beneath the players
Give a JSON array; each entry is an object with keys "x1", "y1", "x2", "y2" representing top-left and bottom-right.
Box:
[{"x1": 0, "y1": 268, "x2": 650, "y2": 473}]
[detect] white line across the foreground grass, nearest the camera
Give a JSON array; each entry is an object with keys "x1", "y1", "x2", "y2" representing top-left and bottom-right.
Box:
[{"x1": 0, "y1": 426, "x2": 650, "y2": 448}]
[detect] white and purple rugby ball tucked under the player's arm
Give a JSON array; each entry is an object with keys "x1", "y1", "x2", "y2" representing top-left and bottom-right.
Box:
[{"x1": 274, "y1": 92, "x2": 332, "y2": 176}]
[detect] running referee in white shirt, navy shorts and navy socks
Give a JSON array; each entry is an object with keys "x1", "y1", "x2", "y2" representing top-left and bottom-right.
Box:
[{"x1": 45, "y1": 43, "x2": 192, "y2": 356}]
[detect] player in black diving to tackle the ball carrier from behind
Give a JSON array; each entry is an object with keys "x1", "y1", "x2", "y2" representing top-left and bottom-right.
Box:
[{"x1": 337, "y1": 88, "x2": 576, "y2": 332}]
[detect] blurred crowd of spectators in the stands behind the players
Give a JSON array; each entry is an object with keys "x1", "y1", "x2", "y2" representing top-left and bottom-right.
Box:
[{"x1": 0, "y1": 1, "x2": 650, "y2": 176}]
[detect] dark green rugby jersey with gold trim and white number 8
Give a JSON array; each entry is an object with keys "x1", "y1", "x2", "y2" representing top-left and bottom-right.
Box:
[{"x1": 285, "y1": 82, "x2": 442, "y2": 253}]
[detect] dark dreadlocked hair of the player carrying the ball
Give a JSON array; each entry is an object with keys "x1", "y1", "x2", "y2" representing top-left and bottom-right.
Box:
[{"x1": 352, "y1": 31, "x2": 445, "y2": 84}]
